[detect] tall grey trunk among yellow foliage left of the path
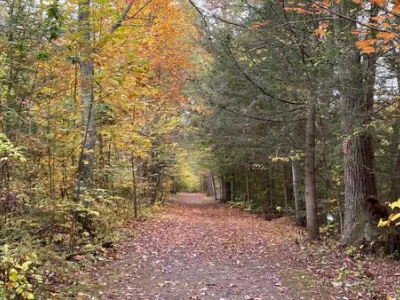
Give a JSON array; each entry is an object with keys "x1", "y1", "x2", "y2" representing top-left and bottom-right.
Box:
[{"x1": 78, "y1": 0, "x2": 96, "y2": 187}]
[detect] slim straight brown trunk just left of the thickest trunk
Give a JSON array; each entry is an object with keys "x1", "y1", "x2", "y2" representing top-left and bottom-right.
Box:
[{"x1": 304, "y1": 91, "x2": 319, "y2": 240}]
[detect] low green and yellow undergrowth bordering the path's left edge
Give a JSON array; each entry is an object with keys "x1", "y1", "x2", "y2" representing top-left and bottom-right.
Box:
[{"x1": 0, "y1": 189, "x2": 156, "y2": 299}]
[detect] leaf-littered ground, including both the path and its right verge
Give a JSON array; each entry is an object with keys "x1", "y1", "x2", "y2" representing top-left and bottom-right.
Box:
[{"x1": 53, "y1": 193, "x2": 400, "y2": 300}]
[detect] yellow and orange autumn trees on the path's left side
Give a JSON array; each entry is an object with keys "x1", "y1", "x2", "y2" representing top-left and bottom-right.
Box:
[{"x1": 0, "y1": 0, "x2": 195, "y2": 288}]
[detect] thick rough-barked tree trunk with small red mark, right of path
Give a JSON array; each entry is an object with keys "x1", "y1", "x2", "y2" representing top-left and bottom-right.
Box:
[{"x1": 339, "y1": 50, "x2": 376, "y2": 245}]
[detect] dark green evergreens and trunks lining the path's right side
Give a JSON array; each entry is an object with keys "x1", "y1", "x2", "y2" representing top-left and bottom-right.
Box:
[{"x1": 192, "y1": 0, "x2": 400, "y2": 251}]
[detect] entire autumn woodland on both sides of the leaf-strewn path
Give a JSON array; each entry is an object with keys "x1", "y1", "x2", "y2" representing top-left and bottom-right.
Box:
[{"x1": 0, "y1": 0, "x2": 400, "y2": 299}]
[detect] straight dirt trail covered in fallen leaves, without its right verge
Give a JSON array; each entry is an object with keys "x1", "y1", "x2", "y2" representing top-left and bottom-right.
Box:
[{"x1": 90, "y1": 194, "x2": 300, "y2": 300}]
